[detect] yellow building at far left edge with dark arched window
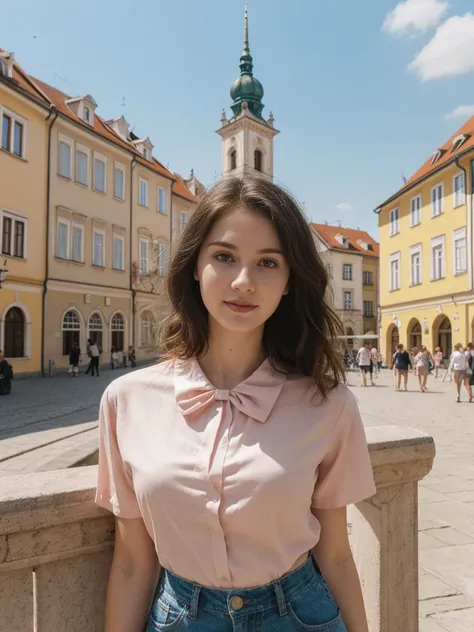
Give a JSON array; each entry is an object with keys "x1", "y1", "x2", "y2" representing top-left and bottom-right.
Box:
[{"x1": 0, "y1": 49, "x2": 51, "y2": 375}]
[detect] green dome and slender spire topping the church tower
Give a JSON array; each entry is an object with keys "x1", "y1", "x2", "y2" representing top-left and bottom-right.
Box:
[{"x1": 230, "y1": 0, "x2": 264, "y2": 119}]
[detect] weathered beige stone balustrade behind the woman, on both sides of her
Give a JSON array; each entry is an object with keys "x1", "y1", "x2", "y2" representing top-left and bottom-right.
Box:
[{"x1": 0, "y1": 426, "x2": 435, "y2": 632}]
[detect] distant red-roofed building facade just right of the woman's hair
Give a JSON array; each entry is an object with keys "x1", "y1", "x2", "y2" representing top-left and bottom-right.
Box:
[{"x1": 311, "y1": 224, "x2": 379, "y2": 346}]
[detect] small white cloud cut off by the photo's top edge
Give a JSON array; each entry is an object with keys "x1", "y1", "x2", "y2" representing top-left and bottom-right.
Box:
[{"x1": 382, "y1": 0, "x2": 449, "y2": 35}]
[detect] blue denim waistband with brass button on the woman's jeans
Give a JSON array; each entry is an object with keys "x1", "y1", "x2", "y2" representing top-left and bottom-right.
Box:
[{"x1": 158, "y1": 555, "x2": 321, "y2": 619}]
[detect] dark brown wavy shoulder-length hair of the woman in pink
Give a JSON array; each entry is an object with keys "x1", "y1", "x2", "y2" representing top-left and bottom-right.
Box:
[{"x1": 161, "y1": 176, "x2": 345, "y2": 397}]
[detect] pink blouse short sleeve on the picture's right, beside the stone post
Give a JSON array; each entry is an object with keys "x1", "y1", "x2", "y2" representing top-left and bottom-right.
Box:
[{"x1": 312, "y1": 389, "x2": 376, "y2": 509}]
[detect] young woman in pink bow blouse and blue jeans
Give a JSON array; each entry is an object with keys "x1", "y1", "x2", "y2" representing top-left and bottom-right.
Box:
[{"x1": 96, "y1": 177, "x2": 376, "y2": 632}]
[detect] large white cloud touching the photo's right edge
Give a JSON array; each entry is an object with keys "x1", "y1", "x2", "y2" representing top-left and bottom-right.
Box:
[{"x1": 408, "y1": 13, "x2": 474, "y2": 81}]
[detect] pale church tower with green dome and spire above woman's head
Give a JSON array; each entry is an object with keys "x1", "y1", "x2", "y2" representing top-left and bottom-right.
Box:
[{"x1": 217, "y1": 0, "x2": 279, "y2": 180}]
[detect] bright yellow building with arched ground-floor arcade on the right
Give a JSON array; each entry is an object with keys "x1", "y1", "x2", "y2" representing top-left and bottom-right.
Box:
[{"x1": 376, "y1": 117, "x2": 474, "y2": 363}]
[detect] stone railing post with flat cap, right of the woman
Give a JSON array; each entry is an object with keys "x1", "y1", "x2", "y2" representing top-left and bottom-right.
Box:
[{"x1": 348, "y1": 426, "x2": 435, "y2": 632}]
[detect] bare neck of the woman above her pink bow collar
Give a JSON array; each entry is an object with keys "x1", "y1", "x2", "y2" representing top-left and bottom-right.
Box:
[{"x1": 199, "y1": 323, "x2": 265, "y2": 389}]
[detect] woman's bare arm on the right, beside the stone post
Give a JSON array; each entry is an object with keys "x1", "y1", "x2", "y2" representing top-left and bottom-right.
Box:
[{"x1": 312, "y1": 507, "x2": 368, "y2": 632}]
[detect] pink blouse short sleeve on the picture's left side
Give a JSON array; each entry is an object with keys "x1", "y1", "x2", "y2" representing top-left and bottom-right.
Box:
[{"x1": 95, "y1": 387, "x2": 142, "y2": 518}]
